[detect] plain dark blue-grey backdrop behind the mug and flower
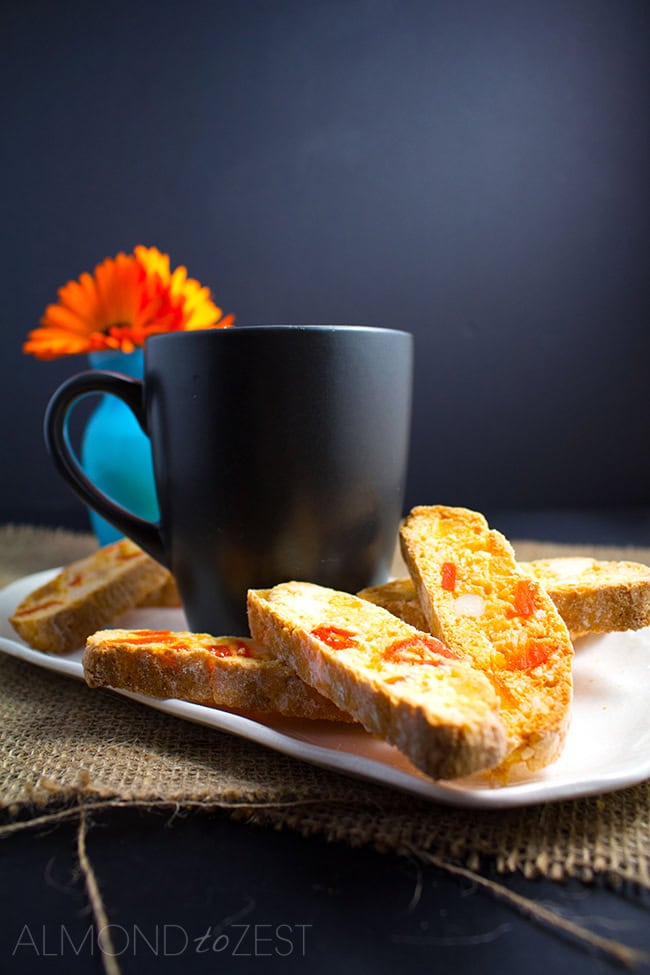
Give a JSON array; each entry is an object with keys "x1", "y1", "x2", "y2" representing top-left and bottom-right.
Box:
[{"x1": 0, "y1": 0, "x2": 650, "y2": 528}]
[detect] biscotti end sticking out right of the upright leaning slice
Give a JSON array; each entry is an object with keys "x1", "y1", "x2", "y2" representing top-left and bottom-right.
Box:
[{"x1": 519, "y1": 557, "x2": 650, "y2": 634}]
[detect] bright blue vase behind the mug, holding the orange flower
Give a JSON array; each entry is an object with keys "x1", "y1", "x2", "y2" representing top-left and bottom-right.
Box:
[{"x1": 81, "y1": 349, "x2": 159, "y2": 545}]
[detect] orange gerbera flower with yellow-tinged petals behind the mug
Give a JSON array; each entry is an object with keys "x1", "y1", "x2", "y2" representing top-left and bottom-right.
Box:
[{"x1": 23, "y1": 246, "x2": 234, "y2": 359}]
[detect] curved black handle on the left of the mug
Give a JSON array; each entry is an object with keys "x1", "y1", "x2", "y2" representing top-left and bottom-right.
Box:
[{"x1": 43, "y1": 369, "x2": 167, "y2": 565}]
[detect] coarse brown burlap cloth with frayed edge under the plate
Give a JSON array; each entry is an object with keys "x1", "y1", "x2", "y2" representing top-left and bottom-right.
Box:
[{"x1": 0, "y1": 527, "x2": 650, "y2": 887}]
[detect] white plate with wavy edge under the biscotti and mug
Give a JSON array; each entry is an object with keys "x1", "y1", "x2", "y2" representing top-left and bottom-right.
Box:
[{"x1": 0, "y1": 569, "x2": 650, "y2": 809}]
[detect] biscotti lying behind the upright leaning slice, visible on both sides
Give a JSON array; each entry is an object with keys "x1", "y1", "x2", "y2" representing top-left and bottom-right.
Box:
[{"x1": 358, "y1": 556, "x2": 650, "y2": 639}]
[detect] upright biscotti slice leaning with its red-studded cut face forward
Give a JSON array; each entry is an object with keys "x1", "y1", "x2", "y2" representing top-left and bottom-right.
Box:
[{"x1": 400, "y1": 505, "x2": 573, "y2": 778}]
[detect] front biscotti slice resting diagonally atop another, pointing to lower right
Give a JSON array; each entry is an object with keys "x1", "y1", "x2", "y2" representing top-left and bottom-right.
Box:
[{"x1": 248, "y1": 582, "x2": 506, "y2": 779}]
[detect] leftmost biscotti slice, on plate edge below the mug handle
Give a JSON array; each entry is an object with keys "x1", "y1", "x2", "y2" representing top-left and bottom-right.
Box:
[{"x1": 10, "y1": 538, "x2": 169, "y2": 653}]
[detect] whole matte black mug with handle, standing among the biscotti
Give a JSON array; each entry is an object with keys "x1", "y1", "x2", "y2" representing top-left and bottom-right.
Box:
[{"x1": 45, "y1": 325, "x2": 413, "y2": 636}]
